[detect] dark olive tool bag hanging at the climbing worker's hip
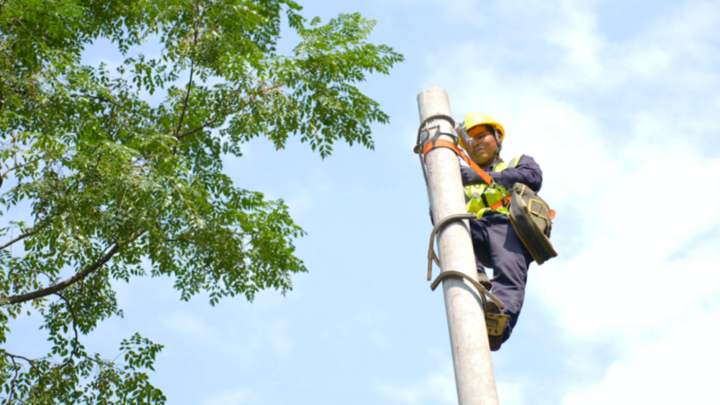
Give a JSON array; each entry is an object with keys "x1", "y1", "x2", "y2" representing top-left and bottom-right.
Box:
[{"x1": 508, "y1": 183, "x2": 557, "y2": 264}]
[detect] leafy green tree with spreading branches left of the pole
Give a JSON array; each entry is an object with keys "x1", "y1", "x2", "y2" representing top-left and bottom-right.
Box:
[{"x1": 0, "y1": 0, "x2": 403, "y2": 404}]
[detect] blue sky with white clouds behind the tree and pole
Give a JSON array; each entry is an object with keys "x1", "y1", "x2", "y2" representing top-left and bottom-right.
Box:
[{"x1": 9, "y1": 0, "x2": 720, "y2": 405}]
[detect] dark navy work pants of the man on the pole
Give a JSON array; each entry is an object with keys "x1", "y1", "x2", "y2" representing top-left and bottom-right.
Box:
[{"x1": 470, "y1": 214, "x2": 533, "y2": 342}]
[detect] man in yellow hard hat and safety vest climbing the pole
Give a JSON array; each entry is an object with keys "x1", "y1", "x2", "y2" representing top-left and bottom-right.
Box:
[{"x1": 460, "y1": 112, "x2": 542, "y2": 351}]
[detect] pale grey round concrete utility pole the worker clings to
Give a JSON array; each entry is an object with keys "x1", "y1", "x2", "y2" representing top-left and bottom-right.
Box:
[{"x1": 418, "y1": 87, "x2": 498, "y2": 405}]
